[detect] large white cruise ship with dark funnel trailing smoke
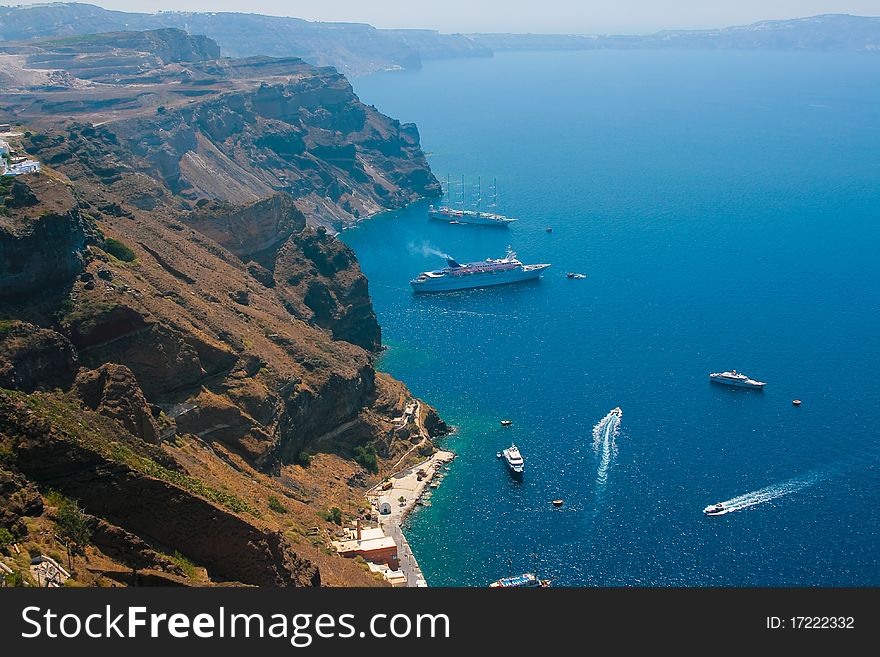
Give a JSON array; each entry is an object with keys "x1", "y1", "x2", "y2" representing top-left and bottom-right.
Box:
[{"x1": 410, "y1": 249, "x2": 550, "y2": 292}]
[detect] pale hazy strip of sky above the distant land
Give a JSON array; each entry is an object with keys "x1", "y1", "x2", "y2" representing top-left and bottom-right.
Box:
[{"x1": 31, "y1": 0, "x2": 880, "y2": 34}]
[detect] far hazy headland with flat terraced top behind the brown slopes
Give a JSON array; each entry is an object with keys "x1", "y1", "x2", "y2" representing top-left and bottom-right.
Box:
[{"x1": 0, "y1": 30, "x2": 440, "y2": 230}]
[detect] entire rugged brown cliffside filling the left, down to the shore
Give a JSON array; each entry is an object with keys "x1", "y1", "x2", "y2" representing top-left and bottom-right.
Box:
[{"x1": 0, "y1": 30, "x2": 445, "y2": 585}]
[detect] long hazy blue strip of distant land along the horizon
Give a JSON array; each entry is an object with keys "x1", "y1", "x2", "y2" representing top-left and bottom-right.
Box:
[{"x1": 0, "y1": 2, "x2": 880, "y2": 76}]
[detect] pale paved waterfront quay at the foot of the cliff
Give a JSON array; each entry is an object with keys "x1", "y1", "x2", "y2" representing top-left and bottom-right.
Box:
[{"x1": 366, "y1": 449, "x2": 456, "y2": 587}]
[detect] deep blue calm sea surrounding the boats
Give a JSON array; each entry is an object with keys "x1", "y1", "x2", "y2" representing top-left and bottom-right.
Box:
[{"x1": 344, "y1": 52, "x2": 880, "y2": 586}]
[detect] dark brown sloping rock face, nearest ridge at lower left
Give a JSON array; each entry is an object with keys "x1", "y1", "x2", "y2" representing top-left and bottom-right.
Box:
[{"x1": 0, "y1": 393, "x2": 320, "y2": 586}]
